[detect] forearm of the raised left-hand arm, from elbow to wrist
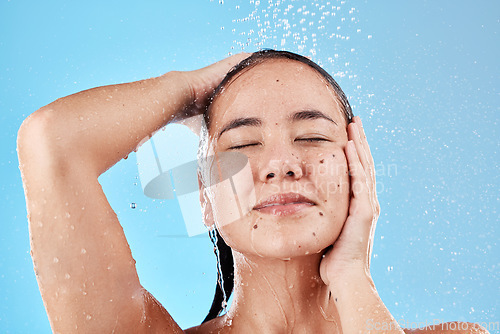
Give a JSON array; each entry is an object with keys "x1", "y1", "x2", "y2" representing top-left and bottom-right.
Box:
[{"x1": 28, "y1": 72, "x2": 192, "y2": 175}]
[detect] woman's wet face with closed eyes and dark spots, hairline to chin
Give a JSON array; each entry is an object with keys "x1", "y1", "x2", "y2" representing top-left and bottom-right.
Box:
[{"x1": 203, "y1": 59, "x2": 350, "y2": 259}]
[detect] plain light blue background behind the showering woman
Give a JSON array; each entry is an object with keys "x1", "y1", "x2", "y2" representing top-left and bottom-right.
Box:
[{"x1": 0, "y1": 0, "x2": 500, "y2": 333}]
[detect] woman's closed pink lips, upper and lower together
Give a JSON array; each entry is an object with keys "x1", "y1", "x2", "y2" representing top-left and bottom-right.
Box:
[{"x1": 254, "y1": 193, "x2": 316, "y2": 216}]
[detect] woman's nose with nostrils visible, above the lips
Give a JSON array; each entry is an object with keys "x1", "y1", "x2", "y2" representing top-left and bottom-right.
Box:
[{"x1": 259, "y1": 147, "x2": 304, "y2": 183}]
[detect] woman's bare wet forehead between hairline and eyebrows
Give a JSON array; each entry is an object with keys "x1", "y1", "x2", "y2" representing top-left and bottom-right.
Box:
[{"x1": 210, "y1": 59, "x2": 343, "y2": 128}]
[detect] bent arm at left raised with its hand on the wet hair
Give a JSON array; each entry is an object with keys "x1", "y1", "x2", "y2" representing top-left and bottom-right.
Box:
[{"x1": 18, "y1": 54, "x2": 245, "y2": 333}]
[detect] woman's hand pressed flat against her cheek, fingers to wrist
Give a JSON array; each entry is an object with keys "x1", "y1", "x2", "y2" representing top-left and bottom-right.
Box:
[{"x1": 320, "y1": 117, "x2": 380, "y2": 285}]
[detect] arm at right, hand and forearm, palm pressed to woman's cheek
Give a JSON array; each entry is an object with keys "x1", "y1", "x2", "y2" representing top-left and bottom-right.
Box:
[{"x1": 320, "y1": 116, "x2": 404, "y2": 334}]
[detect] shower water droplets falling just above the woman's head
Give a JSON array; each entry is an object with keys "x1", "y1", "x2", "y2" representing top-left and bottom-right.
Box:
[{"x1": 212, "y1": 0, "x2": 373, "y2": 109}]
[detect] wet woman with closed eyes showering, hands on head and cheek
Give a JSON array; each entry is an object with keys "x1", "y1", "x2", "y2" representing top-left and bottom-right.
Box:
[{"x1": 18, "y1": 51, "x2": 481, "y2": 333}]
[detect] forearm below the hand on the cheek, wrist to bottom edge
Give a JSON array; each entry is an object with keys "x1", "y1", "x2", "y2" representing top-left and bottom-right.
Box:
[{"x1": 329, "y1": 274, "x2": 404, "y2": 334}]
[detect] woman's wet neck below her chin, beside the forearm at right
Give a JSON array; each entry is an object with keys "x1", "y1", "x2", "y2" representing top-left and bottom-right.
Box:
[{"x1": 227, "y1": 251, "x2": 340, "y2": 333}]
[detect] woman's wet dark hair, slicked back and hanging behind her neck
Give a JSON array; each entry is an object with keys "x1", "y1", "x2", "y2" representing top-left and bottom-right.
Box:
[{"x1": 203, "y1": 49, "x2": 354, "y2": 322}]
